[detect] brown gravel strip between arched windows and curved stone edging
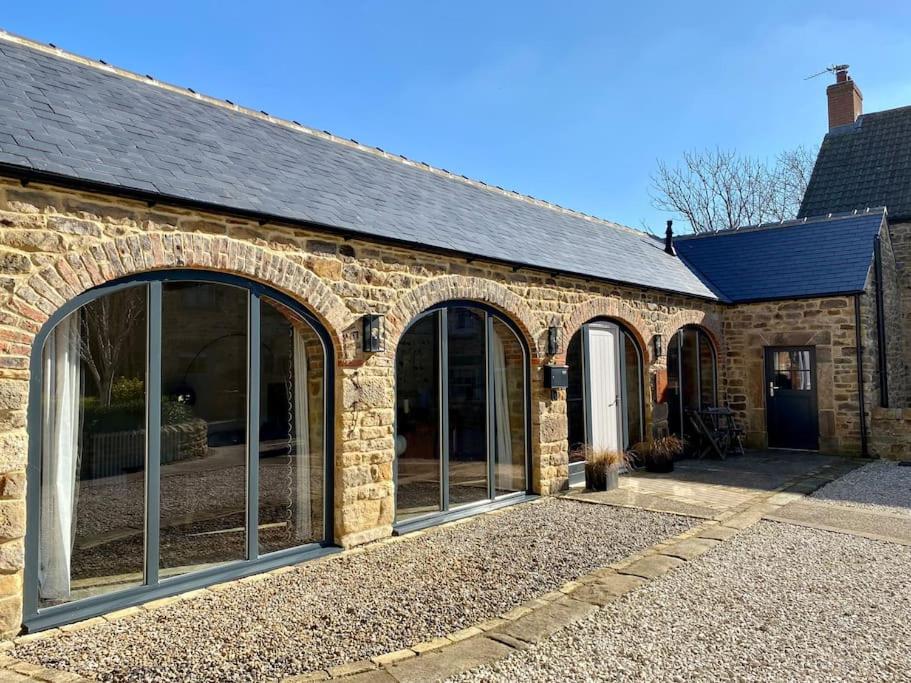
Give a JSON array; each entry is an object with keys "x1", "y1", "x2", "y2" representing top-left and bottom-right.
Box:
[{"x1": 12, "y1": 499, "x2": 695, "y2": 681}]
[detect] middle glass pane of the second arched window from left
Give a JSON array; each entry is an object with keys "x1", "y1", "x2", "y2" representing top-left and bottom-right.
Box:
[{"x1": 447, "y1": 307, "x2": 488, "y2": 507}]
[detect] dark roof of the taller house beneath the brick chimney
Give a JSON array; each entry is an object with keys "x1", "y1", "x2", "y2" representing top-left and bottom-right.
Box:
[{"x1": 798, "y1": 107, "x2": 911, "y2": 221}]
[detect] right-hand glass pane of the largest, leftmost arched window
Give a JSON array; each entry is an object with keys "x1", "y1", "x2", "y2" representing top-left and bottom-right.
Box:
[{"x1": 259, "y1": 298, "x2": 325, "y2": 554}]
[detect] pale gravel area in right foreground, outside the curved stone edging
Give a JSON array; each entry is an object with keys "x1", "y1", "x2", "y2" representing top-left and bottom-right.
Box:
[{"x1": 452, "y1": 522, "x2": 911, "y2": 683}]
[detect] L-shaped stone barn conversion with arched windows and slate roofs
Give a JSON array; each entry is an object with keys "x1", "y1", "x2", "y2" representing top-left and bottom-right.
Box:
[{"x1": 0, "y1": 34, "x2": 911, "y2": 635}]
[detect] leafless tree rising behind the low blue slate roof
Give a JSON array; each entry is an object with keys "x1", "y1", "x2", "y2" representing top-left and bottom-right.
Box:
[{"x1": 650, "y1": 147, "x2": 816, "y2": 232}]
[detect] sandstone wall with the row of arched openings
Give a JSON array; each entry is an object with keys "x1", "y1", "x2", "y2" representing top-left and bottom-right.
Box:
[{"x1": 0, "y1": 179, "x2": 725, "y2": 634}]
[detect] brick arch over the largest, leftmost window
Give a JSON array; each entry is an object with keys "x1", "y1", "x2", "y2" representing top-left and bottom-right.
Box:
[{"x1": 10, "y1": 233, "x2": 354, "y2": 348}]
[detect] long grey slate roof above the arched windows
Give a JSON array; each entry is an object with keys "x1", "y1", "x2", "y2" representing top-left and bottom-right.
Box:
[{"x1": 0, "y1": 34, "x2": 715, "y2": 298}]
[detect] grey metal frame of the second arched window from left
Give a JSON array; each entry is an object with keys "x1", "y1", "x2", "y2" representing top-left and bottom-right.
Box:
[{"x1": 393, "y1": 299, "x2": 534, "y2": 534}]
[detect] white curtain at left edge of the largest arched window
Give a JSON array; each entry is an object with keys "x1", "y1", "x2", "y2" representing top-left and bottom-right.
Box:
[{"x1": 38, "y1": 311, "x2": 81, "y2": 600}]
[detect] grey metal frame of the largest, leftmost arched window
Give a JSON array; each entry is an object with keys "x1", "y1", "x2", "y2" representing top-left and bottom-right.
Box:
[{"x1": 23, "y1": 269, "x2": 340, "y2": 632}]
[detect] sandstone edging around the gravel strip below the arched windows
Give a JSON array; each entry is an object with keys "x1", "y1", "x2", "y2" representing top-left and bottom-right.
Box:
[{"x1": 0, "y1": 461, "x2": 865, "y2": 683}]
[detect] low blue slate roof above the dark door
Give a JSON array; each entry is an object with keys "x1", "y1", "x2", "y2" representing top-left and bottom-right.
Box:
[{"x1": 675, "y1": 209, "x2": 885, "y2": 303}]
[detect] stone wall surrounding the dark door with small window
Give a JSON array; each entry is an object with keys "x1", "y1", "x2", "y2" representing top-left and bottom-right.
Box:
[{"x1": 724, "y1": 296, "x2": 875, "y2": 455}]
